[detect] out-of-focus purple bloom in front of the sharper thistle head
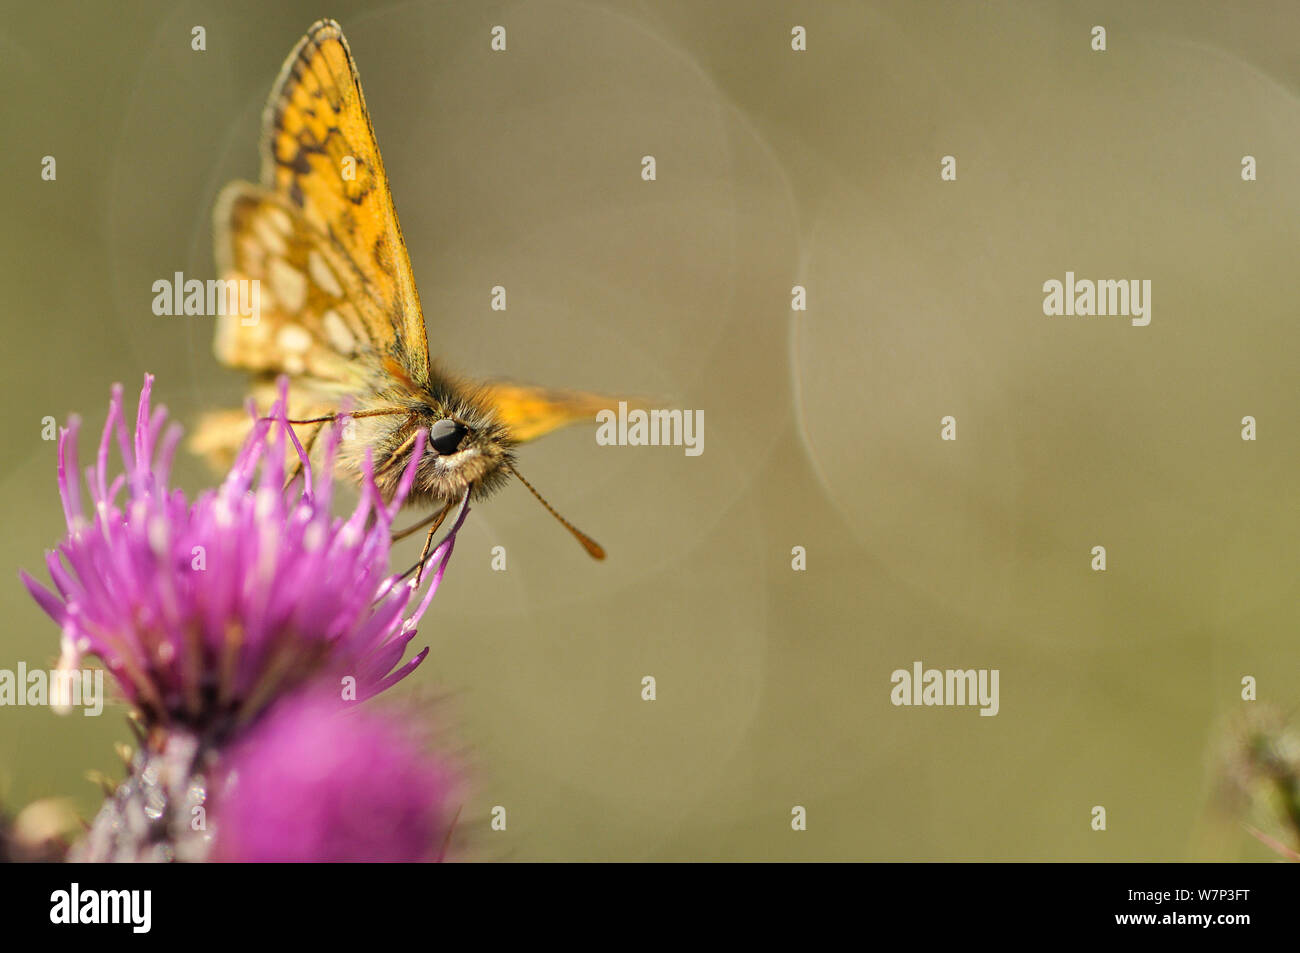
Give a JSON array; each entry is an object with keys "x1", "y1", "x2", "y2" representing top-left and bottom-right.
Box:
[{"x1": 211, "y1": 692, "x2": 456, "y2": 863}]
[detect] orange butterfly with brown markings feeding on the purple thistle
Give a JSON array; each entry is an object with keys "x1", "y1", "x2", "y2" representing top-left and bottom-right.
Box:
[{"x1": 191, "y1": 20, "x2": 611, "y2": 569}]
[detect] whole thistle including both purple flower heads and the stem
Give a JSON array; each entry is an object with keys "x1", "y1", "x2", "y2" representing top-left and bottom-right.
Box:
[{"x1": 21, "y1": 376, "x2": 468, "y2": 861}]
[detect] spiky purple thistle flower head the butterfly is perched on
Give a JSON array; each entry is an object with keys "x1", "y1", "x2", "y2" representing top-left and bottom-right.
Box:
[{"x1": 21, "y1": 376, "x2": 468, "y2": 736}]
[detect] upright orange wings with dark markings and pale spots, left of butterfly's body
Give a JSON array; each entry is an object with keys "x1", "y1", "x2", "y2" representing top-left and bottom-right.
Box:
[{"x1": 190, "y1": 21, "x2": 430, "y2": 467}]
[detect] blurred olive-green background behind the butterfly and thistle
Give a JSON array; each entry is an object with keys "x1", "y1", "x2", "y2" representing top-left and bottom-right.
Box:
[{"x1": 0, "y1": 0, "x2": 1300, "y2": 859}]
